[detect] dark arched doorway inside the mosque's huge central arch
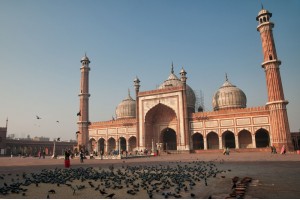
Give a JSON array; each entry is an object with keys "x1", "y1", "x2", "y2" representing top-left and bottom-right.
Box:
[{"x1": 160, "y1": 128, "x2": 177, "y2": 150}]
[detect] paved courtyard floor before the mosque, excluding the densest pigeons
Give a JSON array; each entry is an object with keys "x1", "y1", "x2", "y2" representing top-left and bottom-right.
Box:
[{"x1": 0, "y1": 152, "x2": 300, "y2": 199}]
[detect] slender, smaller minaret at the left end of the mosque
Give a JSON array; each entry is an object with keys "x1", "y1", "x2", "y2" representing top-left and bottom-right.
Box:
[{"x1": 77, "y1": 55, "x2": 90, "y2": 151}]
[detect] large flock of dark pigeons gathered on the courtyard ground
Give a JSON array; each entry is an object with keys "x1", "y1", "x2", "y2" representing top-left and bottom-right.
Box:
[{"x1": 0, "y1": 161, "x2": 249, "y2": 199}]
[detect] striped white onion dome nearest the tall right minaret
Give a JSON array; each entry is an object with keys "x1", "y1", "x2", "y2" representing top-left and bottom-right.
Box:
[{"x1": 212, "y1": 77, "x2": 247, "y2": 110}]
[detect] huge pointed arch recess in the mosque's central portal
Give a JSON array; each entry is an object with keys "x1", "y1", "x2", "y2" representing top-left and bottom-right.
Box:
[{"x1": 142, "y1": 103, "x2": 177, "y2": 149}]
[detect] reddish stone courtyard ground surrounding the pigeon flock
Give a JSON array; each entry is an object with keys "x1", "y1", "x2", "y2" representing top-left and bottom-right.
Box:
[{"x1": 0, "y1": 152, "x2": 300, "y2": 199}]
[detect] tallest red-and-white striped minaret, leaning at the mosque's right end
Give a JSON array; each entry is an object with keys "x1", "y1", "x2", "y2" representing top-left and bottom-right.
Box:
[{"x1": 256, "y1": 7, "x2": 293, "y2": 150}]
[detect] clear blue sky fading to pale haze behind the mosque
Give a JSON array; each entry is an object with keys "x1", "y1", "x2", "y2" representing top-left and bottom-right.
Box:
[{"x1": 0, "y1": 0, "x2": 300, "y2": 140}]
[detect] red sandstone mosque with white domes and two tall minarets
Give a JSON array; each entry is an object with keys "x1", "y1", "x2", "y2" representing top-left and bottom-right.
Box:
[{"x1": 77, "y1": 8, "x2": 293, "y2": 153}]
